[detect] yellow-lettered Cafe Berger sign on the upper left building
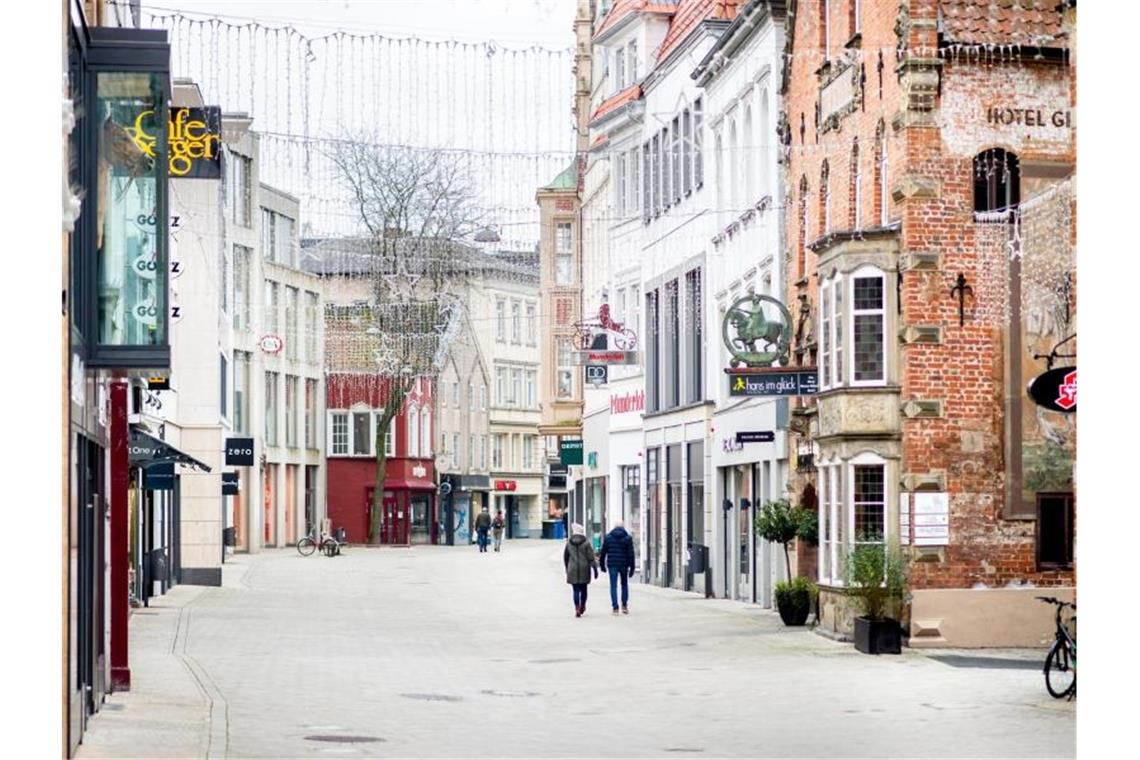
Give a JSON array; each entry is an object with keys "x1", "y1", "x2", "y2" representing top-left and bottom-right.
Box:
[{"x1": 128, "y1": 106, "x2": 221, "y2": 179}]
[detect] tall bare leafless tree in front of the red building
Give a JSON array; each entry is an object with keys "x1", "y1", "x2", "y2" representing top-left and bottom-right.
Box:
[{"x1": 328, "y1": 140, "x2": 479, "y2": 542}]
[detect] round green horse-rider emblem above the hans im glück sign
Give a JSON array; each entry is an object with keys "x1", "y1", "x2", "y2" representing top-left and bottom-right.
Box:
[{"x1": 720, "y1": 293, "x2": 792, "y2": 367}]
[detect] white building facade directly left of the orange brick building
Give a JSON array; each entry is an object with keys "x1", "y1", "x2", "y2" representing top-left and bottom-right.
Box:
[{"x1": 694, "y1": 0, "x2": 788, "y2": 607}]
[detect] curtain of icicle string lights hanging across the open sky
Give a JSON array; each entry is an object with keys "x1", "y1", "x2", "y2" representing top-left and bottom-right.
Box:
[{"x1": 143, "y1": 9, "x2": 575, "y2": 251}]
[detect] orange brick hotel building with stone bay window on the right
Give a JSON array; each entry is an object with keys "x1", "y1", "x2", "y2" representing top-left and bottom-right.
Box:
[{"x1": 779, "y1": 0, "x2": 1076, "y2": 646}]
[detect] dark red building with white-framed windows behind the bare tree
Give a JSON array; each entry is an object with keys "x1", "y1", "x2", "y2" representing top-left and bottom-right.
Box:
[{"x1": 326, "y1": 374, "x2": 440, "y2": 546}]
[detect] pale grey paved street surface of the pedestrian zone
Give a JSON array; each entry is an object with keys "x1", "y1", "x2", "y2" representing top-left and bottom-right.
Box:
[{"x1": 79, "y1": 540, "x2": 1075, "y2": 759}]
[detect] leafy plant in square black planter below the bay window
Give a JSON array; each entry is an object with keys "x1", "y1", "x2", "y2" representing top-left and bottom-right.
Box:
[{"x1": 846, "y1": 544, "x2": 906, "y2": 654}]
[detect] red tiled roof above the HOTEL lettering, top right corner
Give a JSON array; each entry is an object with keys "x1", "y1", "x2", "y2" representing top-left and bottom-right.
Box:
[{"x1": 938, "y1": 0, "x2": 1061, "y2": 47}]
